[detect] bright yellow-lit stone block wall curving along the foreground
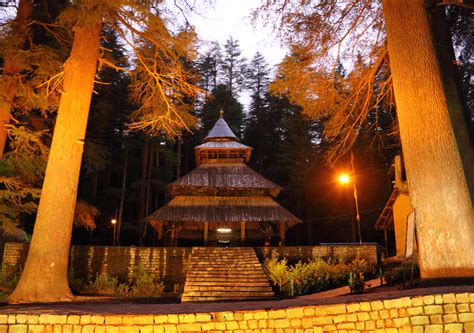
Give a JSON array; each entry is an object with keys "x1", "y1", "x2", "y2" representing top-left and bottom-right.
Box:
[{"x1": 0, "y1": 293, "x2": 474, "y2": 333}]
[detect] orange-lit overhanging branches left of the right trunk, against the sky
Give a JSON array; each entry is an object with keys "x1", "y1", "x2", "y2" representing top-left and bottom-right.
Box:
[{"x1": 254, "y1": 0, "x2": 396, "y2": 163}]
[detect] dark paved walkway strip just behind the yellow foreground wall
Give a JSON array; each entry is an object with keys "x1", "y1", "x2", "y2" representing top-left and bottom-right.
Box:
[{"x1": 0, "y1": 281, "x2": 474, "y2": 315}]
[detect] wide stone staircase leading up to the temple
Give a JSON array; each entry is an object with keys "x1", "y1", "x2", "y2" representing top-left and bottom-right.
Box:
[{"x1": 181, "y1": 247, "x2": 274, "y2": 302}]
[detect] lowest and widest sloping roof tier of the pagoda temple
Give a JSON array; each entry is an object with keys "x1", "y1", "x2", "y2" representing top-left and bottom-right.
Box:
[{"x1": 147, "y1": 196, "x2": 301, "y2": 228}]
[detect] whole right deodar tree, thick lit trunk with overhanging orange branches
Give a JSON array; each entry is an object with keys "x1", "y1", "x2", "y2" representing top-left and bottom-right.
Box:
[{"x1": 257, "y1": 0, "x2": 474, "y2": 279}]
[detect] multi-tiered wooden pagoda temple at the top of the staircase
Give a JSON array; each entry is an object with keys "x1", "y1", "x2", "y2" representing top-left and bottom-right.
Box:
[{"x1": 147, "y1": 111, "x2": 301, "y2": 246}]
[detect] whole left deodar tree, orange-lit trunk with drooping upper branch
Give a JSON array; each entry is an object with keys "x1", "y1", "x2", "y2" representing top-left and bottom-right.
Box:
[{"x1": 8, "y1": 0, "x2": 200, "y2": 303}]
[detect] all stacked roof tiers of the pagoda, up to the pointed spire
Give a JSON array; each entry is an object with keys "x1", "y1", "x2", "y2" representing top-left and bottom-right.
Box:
[{"x1": 148, "y1": 112, "x2": 300, "y2": 227}]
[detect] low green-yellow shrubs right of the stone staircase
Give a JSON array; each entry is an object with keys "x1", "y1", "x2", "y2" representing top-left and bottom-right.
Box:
[{"x1": 264, "y1": 256, "x2": 372, "y2": 296}]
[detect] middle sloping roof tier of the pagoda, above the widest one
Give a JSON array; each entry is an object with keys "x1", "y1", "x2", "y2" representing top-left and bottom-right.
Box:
[{"x1": 169, "y1": 163, "x2": 282, "y2": 197}]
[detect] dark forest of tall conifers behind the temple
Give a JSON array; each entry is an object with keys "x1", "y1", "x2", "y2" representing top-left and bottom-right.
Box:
[{"x1": 0, "y1": 1, "x2": 473, "y2": 253}]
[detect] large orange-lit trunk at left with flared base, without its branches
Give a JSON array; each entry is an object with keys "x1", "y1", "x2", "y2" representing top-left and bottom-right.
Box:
[{"x1": 8, "y1": 13, "x2": 101, "y2": 303}]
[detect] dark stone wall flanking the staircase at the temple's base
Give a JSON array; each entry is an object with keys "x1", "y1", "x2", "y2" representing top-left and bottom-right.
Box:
[{"x1": 2, "y1": 243, "x2": 378, "y2": 292}]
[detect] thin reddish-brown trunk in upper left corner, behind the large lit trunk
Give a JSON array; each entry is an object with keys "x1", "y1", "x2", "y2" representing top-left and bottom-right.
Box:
[{"x1": 0, "y1": 0, "x2": 33, "y2": 159}]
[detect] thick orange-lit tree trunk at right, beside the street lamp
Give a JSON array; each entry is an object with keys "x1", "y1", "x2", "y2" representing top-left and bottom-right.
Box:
[{"x1": 382, "y1": 0, "x2": 474, "y2": 279}]
